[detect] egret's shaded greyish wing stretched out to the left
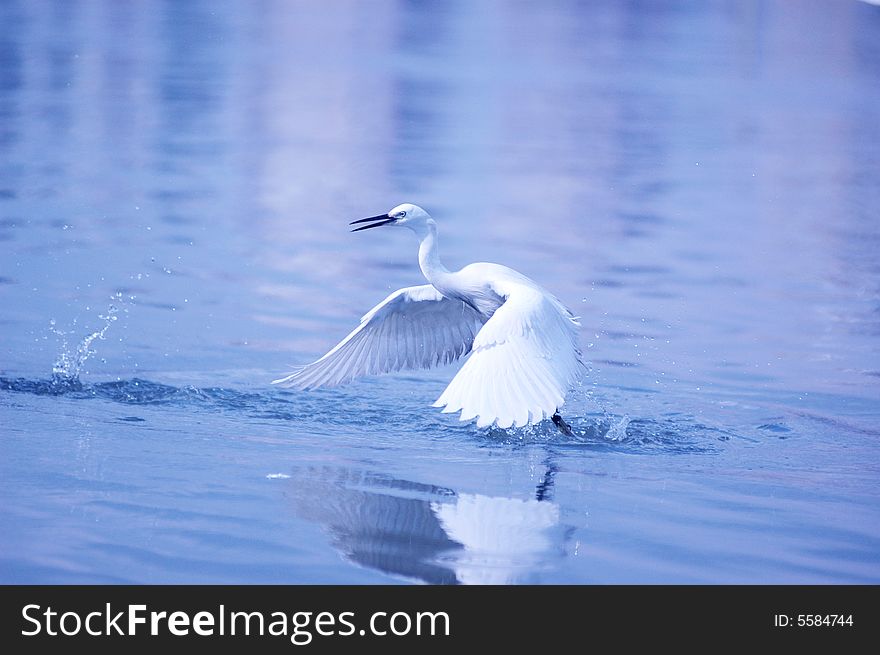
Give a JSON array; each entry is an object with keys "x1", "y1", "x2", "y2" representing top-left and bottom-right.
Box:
[{"x1": 272, "y1": 284, "x2": 483, "y2": 389}]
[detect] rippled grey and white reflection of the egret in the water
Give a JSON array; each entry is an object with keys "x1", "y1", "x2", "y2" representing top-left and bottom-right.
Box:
[{"x1": 288, "y1": 466, "x2": 569, "y2": 584}]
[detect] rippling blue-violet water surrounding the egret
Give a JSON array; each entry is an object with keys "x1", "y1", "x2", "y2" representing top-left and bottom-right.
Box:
[{"x1": 0, "y1": 0, "x2": 880, "y2": 583}]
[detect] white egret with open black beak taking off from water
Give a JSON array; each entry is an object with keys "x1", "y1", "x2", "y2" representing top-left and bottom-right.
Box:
[{"x1": 273, "y1": 203, "x2": 583, "y2": 434}]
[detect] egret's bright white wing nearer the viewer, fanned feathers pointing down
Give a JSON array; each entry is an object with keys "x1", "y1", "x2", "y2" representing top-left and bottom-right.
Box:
[{"x1": 434, "y1": 281, "x2": 583, "y2": 428}]
